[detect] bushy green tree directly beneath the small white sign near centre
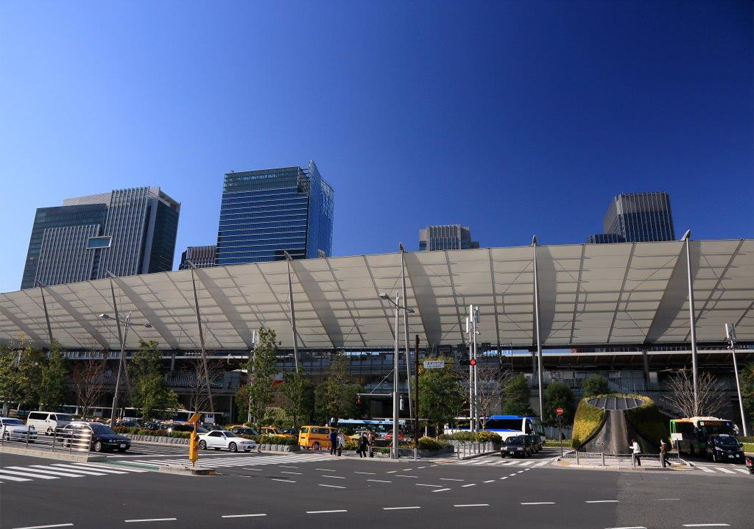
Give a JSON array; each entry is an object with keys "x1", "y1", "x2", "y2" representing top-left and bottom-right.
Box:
[{"x1": 419, "y1": 358, "x2": 466, "y2": 434}]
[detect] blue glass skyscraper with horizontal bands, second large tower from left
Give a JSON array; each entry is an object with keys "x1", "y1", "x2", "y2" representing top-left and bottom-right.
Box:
[{"x1": 216, "y1": 161, "x2": 334, "y2": 266}]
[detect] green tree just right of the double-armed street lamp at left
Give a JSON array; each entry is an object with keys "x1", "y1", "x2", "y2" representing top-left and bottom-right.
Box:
[{"x1": 129, "y1": 340, "x2": 178, "y2": 420}]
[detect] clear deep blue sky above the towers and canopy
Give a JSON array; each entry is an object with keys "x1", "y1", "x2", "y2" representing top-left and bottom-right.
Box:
[{"x1": 0, "y1": 1, "x2": 754, "y2": 292}]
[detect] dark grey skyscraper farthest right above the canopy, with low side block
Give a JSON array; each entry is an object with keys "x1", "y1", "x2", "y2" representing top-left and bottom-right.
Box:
[{"x1": 587, "y1": 192, "x2": 675, "y2": 244}]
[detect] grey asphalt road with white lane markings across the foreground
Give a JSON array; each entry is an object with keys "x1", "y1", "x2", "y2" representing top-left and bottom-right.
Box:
[{"x1": 0, "y1": 453, "x2": 754, "y2": 529}]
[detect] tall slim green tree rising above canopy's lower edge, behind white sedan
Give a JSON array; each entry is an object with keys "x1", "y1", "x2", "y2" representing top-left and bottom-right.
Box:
[{"x1": 239, "y1": 327, "x2": 277, "y2": 423}]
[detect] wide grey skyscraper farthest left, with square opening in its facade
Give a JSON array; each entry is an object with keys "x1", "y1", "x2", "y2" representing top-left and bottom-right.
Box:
[{"x1": 21, "y1": 187, "x2": 181, "y2": 289}]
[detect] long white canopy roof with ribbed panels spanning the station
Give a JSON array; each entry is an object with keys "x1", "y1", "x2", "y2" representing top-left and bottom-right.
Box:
[{"x1": 0, "y1": 239, "x2": 754, "y2": 350}]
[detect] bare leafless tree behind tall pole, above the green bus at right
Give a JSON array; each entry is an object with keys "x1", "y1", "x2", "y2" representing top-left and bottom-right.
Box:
[{"x1": 666, "y1": 369, "x2": 726, "y2": 417}]
